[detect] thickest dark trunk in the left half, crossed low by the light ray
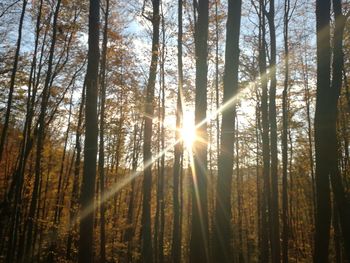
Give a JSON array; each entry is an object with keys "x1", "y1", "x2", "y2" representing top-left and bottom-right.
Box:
[{"x1": 78, "y1": 0, "x2": 100, "y2": 263}]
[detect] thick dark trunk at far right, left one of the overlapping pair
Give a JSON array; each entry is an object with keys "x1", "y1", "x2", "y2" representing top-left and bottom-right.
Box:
[{"x1": 314, "y1": 0, "x2": 333, "y2": 263}]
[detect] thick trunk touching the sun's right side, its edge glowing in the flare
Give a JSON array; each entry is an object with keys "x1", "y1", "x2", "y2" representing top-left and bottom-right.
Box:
[{"x1": 190, "y1": 0, "x2": 210, "y2": 263}]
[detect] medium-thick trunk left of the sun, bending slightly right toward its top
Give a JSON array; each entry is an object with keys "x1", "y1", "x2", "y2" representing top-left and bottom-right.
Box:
[{"x1": 141, "y1": 0, "x2": 160, "y2": 263}]
